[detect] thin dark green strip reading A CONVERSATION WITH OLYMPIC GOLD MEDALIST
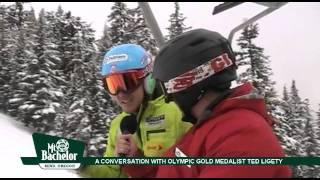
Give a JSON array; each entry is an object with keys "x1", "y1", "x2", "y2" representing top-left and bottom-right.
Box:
[{"x1": 75, "y1": 157, "x2": 320, "y2": 165}]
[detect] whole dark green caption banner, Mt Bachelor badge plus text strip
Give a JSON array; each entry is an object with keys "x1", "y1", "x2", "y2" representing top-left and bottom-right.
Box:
[{"x1": 21, "y1": 133, "x2": 320, "y2": 169}]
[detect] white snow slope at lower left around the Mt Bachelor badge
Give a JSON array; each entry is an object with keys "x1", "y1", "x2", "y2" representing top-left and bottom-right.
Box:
[{"x1": 0, "y1": 113, "x2": 79, "y2": 178}]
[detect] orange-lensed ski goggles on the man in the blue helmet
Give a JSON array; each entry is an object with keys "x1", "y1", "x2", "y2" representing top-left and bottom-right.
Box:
[{"x1": 102, "y1": 69, "x2": 145, "y2": 95}]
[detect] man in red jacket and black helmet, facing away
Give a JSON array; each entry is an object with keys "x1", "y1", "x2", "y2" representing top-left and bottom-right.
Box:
[{"x1": 118, "y1": 29, "x2": 291, "y2": 178}]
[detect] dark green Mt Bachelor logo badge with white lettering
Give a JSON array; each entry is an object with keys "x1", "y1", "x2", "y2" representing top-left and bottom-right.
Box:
[{"x1": 21, "y1": 133, "x2": 84, "y2": 169}]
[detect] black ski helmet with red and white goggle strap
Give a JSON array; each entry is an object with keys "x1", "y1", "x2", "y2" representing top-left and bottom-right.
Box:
[{"x1": 153, "y1": 29, "x2": 237, "y2": 124}]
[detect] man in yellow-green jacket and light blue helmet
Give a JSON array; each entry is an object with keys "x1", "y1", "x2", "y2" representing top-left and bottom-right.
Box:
[{"x1": 81, "y1": 44, "x2": 191, "y2": 177}]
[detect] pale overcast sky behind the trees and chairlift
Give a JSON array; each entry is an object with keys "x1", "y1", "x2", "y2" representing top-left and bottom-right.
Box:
[{"x1": 6, "y1": 2, "x2": 320, "y2": 110}]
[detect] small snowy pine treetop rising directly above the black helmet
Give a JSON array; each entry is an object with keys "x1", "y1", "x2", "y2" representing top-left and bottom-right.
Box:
[{"x1": 166, "y1": 2, "x2": 192, "y2": 40}]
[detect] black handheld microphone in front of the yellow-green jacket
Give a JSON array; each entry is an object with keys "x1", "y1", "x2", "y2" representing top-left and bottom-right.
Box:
[{"x1": 119, "y1": 114, "x2": 138, "y2": 157}]
